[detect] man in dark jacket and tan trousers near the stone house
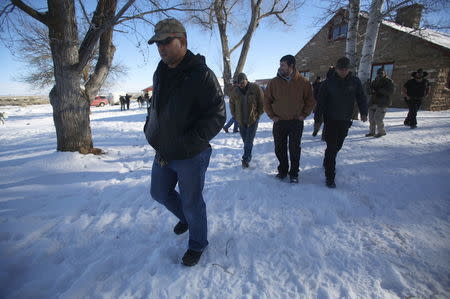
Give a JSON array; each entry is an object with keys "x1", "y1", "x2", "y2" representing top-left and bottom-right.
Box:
[{"x1": 366, "y1": 67, "x2": 394, "y2": 138}]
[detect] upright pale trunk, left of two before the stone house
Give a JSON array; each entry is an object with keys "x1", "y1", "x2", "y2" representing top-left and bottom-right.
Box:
[{"x1": 345, "y1": 0, "x2": 360, "y2": 70}]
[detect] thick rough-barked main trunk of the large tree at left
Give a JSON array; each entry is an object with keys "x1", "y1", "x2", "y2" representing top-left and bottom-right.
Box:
[{"x1": 48, "y1": 0, "x2": 93, "y2": 151}]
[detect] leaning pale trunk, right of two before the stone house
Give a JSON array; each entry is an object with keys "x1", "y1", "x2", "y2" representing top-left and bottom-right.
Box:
[{"x1": 358, "y1": 0, "x2": 384, "y2": 84}]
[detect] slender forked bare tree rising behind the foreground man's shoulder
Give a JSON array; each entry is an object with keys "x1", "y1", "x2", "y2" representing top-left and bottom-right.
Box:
[{"x1": 193, "y1": 0, "x2": 303, "y2": 94}]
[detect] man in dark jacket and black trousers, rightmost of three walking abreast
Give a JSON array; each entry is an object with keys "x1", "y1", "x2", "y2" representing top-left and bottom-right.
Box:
[{"x1": 314, "y1": 57, "x2": 367, "y2": 188}]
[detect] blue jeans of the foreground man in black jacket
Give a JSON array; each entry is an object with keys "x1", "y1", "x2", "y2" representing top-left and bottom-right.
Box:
[{"x1": 150, "y1": 147, "x2": 212, "y2": 251}]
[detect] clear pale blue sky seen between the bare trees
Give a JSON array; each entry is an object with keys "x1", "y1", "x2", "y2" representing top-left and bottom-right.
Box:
[{"x1": 0, "y1": 0, "x2": 321, "y2": 95}]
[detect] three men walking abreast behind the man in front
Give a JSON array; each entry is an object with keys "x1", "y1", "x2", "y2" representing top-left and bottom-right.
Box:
[{"x1": 230, "y1": 55, "x2": 367, "y2": 188}]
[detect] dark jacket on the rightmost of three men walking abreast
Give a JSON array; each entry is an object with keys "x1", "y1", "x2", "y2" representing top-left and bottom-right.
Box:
[{"x1": 314, "y1": 72, "x2": 367, "y2": 121}]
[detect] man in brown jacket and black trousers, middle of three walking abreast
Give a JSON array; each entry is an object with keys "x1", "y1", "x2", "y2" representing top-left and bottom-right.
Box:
[{"x1": 264, "y1": 55, "x2": 316, "y2": 183}]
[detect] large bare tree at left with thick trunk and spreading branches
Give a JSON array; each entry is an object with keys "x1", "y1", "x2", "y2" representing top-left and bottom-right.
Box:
[{"x1": 0, "y1": 0, "x2": 200, "y2": 153}]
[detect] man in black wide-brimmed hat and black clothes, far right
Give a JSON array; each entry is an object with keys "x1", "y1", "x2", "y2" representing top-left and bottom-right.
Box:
[{"x1": 402, "y1": 69, "x2": 430, "y2": 129}]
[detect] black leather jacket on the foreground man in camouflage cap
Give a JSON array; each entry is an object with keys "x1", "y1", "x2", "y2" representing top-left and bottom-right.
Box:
[{"x1": 144, "y1": 51, "x2": 226, "y2": 162}]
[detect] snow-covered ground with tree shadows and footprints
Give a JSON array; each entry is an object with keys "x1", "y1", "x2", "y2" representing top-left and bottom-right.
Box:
[{"x1": 0, "y1": 105, "x2": 450, "y2": 299}]
